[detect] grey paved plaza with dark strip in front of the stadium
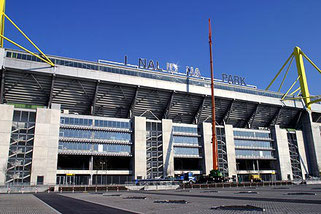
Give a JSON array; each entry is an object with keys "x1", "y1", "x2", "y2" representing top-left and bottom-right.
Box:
[{"x1": 0, "y1": 185, "x2": 321, "y2": 214}]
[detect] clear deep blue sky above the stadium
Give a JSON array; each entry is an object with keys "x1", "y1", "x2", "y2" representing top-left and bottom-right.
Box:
[{"x1": 5, "y1": 0, "x2": 321, "y2": 94}]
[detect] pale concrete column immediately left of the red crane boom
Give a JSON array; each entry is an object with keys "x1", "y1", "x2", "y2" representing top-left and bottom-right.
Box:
[{"x1": 202, "y1": 123, "x2": 213, "y2": 175}]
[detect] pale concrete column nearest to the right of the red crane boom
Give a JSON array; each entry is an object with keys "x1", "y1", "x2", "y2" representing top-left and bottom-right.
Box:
[{"x1": 224, "y1": 125, "x2": 237, "y2": 177}]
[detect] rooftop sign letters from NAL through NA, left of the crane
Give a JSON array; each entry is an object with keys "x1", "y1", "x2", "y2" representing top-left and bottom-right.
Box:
[{"x1": 138, "y1": 58, "x2": 201, "y2": 77}]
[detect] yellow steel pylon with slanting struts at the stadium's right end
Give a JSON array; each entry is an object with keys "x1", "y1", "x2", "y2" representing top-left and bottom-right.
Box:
[{"x1": 265, "y1": 47, "x2": 321, "y2": 109}]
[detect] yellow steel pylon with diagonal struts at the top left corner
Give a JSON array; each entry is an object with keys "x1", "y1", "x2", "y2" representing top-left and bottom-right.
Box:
[{"x1": 0, "y1": 0, "x2": 55, "y2": 66}]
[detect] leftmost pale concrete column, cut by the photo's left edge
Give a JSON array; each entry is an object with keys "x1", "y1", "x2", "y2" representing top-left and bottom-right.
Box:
[{"x1": 0, "y1": 104, "x2": 14, "y2": 186}]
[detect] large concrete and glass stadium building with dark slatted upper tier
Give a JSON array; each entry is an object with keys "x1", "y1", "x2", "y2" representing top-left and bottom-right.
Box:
[{"x1": 0, "y1": 49, "x2": 321, "y2": 185}]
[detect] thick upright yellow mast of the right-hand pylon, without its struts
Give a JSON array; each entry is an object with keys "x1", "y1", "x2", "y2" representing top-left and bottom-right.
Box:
[{"x1": 293, "y1": 47, "x2": 311, "y2": 109}]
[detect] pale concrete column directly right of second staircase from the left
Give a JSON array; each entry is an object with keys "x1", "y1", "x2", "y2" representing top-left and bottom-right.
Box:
[{"x1": 162, "y1": 119, "x2": 175, "y2": 177}]
